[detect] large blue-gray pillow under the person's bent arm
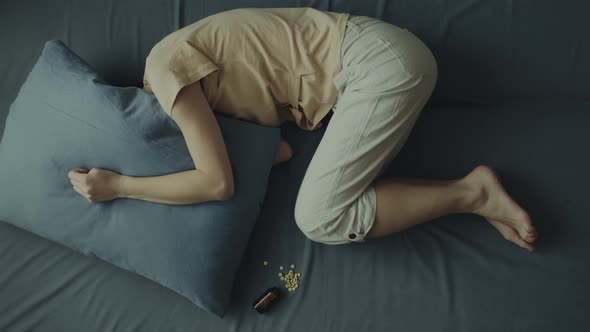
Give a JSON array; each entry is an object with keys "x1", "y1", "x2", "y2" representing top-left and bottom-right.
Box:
[{"x1": 0, "y1": 40, "x2": 280, "y2": 317}]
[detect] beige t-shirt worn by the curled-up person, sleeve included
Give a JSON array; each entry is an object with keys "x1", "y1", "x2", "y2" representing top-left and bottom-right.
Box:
[{"x1": 143, "y1": 7, "x2": 350, "y2": 130}]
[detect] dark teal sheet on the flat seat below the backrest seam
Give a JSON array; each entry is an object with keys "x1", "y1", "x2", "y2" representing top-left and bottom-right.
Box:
[{"x1": 0, "y1": 103, "x2": 590, "y2": 332}]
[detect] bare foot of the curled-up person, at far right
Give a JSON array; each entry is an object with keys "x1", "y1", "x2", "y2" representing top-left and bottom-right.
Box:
[{"x1": 463, "y1": 166, "x2": 537, "y2": 251}]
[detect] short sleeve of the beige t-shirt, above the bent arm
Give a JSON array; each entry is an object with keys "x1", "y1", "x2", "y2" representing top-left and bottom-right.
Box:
[{"x1": 143, "y1": 41, "x2": 219, "y2": 116}]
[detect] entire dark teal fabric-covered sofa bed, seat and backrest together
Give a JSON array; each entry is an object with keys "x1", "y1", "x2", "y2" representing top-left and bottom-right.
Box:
[{"x1": 0, "y1": 0, "x2": 590, "y2": 332}]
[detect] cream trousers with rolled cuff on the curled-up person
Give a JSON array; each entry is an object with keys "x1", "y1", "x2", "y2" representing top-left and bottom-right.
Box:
[{"x1": 295, "y1": 16, "x2": 438, "y2": 244}]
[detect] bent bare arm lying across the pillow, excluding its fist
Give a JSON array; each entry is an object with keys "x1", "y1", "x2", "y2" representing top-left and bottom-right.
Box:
[{"x1": 120, "y1": 81, "x2": 234, "y2": 205}]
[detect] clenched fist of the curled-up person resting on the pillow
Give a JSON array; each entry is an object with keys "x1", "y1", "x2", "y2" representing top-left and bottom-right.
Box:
[{"x1": 68, "y1": 168, "x2": 123, "y2": 203}]
